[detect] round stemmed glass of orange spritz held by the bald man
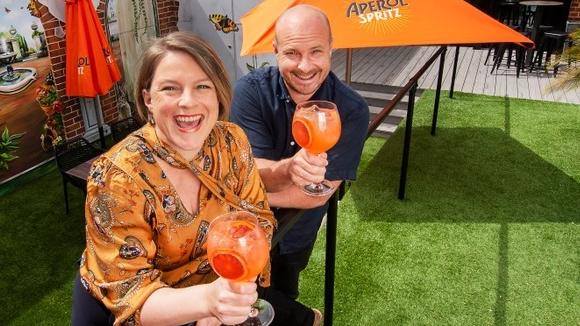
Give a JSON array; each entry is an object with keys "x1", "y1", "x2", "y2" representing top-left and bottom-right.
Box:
[{"x1": 292, "y1": 101, "x2": 341, "y2": 196}]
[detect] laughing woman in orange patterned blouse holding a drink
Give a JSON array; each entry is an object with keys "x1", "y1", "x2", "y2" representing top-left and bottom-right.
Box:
[{"x1": 73, "y1": 32, "x2": 275, "y2": 325}]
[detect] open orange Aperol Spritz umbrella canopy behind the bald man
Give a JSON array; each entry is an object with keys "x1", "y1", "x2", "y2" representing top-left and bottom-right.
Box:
[{"x1": 241, "y1": 0, "x2": 533, "y2": 55}]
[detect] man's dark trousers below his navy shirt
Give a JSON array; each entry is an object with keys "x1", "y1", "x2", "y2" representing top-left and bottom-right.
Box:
[{"x1": 258, "y1": 244, "x2": 314, "y2": 326}]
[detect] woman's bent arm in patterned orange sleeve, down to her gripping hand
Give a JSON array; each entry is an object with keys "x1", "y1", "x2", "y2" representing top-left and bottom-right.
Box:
[{"x1": 81, "y1": 158, "x2": 257, "y2": 325}]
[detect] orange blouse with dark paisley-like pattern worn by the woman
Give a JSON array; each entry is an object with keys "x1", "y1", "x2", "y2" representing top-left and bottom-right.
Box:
[{"x1": 80, "y1": 121, "x2": 276, "y2": 325}]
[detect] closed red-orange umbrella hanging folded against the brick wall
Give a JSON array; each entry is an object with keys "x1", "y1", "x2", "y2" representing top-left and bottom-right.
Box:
[{"x1": 66, "y1": 0, "x2": 121, "y2": 97}]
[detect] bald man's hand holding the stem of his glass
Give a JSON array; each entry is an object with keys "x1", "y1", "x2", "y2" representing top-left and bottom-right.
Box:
[{"x1": 288, "y1": 149, "x2": 328, "y2": 187}]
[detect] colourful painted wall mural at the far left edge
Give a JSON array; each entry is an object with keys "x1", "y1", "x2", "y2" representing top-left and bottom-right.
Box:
[{"x1": 0, "y1": 0, "x2": 53, "y2": 183}]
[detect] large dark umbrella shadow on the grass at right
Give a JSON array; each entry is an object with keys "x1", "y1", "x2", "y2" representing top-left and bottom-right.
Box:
[{"x1": 350, "y1": 127, "x2": 580, "y2": 223}]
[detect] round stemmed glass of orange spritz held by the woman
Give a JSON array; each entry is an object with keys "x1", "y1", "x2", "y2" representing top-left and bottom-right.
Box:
[{"x1": 207, "y1": 211, "x2": 274, "y2": 326}]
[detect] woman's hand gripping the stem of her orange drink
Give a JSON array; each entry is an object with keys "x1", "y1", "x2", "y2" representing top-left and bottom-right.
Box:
[{"x1": 206, "y1": 277, "x2": 258, "y2": 325}]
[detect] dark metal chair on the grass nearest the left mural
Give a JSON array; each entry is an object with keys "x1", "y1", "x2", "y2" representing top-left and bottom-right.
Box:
[{"x1": 54, "y1": 138, "x2": 103, "y2": 215}]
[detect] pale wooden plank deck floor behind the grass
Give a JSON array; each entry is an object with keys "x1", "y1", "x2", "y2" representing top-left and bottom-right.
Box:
[{"x1": 332, "y1": 46, "x2": 580, "y2": 104}]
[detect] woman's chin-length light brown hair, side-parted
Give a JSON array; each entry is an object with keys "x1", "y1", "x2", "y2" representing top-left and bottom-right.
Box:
[{"x1": 135, "y1": 32, "x2": 232, "y2": 120}]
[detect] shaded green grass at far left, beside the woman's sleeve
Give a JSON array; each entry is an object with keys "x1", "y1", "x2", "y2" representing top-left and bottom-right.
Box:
[{"x1": 0, "y1": 170, "x2": 84, "y2": 325}]
